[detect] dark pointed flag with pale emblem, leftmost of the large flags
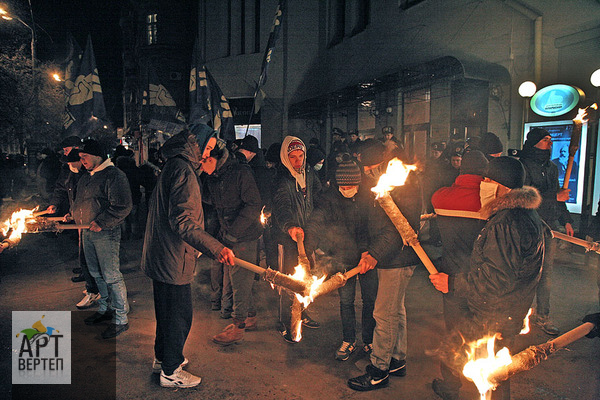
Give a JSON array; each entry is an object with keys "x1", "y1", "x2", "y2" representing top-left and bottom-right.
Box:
[{"x1": 63, "y1": 36, "x2": 106, "y2": 136}]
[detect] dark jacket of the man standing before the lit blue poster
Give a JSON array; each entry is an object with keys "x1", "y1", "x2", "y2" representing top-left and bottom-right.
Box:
[{"x1": 519, "y1": 149, "x2": 573, "y2": 226}]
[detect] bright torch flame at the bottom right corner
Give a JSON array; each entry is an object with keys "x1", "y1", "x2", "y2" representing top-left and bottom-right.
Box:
[{"x1": 463, "y1": 336, "x2": 512, "y2": 400}]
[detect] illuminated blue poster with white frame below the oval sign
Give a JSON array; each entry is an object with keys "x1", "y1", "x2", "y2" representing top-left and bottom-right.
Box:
[{"x1": 524, "y1": 120, "x2": 587, "y2": 214}]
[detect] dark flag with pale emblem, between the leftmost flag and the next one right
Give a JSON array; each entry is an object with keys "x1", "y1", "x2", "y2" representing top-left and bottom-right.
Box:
[{"x1": 142, "y1": 64, "x2": 185, "y2": 134}]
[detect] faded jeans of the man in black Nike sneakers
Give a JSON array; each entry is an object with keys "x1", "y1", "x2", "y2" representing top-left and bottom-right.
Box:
[{"x1": 371, "y1": 265, "x2": 416, "y2": 371}]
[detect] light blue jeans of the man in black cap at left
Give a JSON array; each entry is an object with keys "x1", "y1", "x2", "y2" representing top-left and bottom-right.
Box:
[{"x1": 81, "y1": 226, "x2": 129, "y2": 325}]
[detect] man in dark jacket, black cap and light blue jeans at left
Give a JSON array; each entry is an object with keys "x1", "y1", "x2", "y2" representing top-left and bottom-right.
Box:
[{"x1": 73, "y1": 140, "x2": 131, "y2": 339}]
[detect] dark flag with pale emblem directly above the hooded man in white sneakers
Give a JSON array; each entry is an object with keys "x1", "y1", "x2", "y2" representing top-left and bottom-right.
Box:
[{"x1": 189, "y1": 42, "x2": 235, "y2": 140}]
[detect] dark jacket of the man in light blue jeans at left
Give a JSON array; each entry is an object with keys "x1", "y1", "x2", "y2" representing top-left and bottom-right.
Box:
[{"x1": 72, "y1": 163, "x2": 132, "y2": 230}]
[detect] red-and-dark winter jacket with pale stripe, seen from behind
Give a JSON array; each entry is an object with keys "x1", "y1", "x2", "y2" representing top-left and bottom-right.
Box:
[{"x1": 431, "y1": 174, "x2": 486, "y2": 275}]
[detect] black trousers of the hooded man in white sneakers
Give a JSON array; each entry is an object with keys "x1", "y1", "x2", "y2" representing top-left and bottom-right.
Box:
[{"x1": 152, "y1": 280, "x2": 193, "y2": 375}]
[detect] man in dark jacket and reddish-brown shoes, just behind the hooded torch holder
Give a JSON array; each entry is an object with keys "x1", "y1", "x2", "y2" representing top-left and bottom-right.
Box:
[{"x1": 202, "y1": 140, "x2": 262, "y2": 346}]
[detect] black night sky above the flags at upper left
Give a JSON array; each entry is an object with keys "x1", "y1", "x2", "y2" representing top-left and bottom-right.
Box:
[{"x1": 27, "y1": 0, "x2": 123, "y2": 127}]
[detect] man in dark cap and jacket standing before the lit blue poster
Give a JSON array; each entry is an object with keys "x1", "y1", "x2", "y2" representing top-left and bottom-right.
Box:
[{"x1": 520, "y1": 128, "x2": 573, "y2": 336}]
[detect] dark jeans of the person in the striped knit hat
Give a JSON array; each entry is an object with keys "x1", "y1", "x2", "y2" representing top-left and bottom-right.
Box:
[{"x1": 338, "y1": 269, "x2": 378, "y2": 344}]
